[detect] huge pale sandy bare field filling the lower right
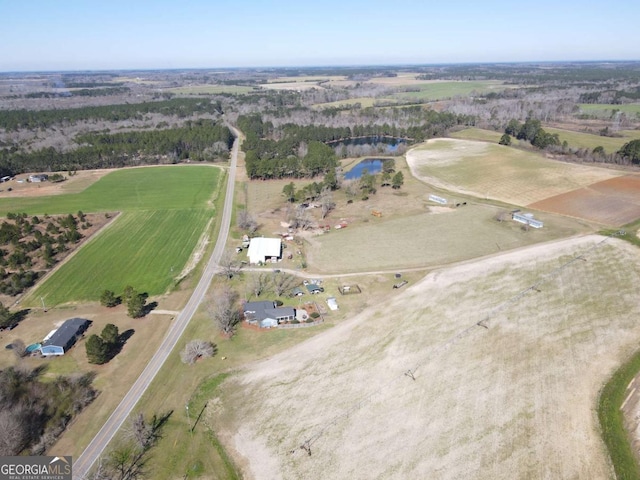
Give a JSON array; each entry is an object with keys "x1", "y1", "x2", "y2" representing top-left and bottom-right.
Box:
[{"x1": 215, "y1": 235, "x2": 640, "y2": 480}]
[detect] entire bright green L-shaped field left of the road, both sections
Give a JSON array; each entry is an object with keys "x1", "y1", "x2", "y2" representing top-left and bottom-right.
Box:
[{"x1": 0, "y1": 166, "x2": 220, "y2": 306}]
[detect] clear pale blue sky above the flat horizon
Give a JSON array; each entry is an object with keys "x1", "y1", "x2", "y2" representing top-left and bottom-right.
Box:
[{"x1": 0, "y1": 0, "x2": 640, "y2": 71}]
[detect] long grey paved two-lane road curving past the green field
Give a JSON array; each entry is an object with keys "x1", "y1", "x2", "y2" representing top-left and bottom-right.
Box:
[{"x1": 73, "y1": 125, "x2": 240, "y2": 479}]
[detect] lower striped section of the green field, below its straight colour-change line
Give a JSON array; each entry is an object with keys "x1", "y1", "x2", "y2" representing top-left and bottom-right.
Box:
[{"x1": 23, "y1": 209, "x2": 212, "y2": 306}]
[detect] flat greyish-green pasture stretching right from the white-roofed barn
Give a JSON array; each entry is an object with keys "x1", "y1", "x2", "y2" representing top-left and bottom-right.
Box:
[{"x1": 306, "y1": 204, "x2": 581, "y2": 273}]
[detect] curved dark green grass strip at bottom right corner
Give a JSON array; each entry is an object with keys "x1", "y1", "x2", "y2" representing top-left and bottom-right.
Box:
[{"x1": 598, "y1": 351, "x2": 640, "y2": 480}]
